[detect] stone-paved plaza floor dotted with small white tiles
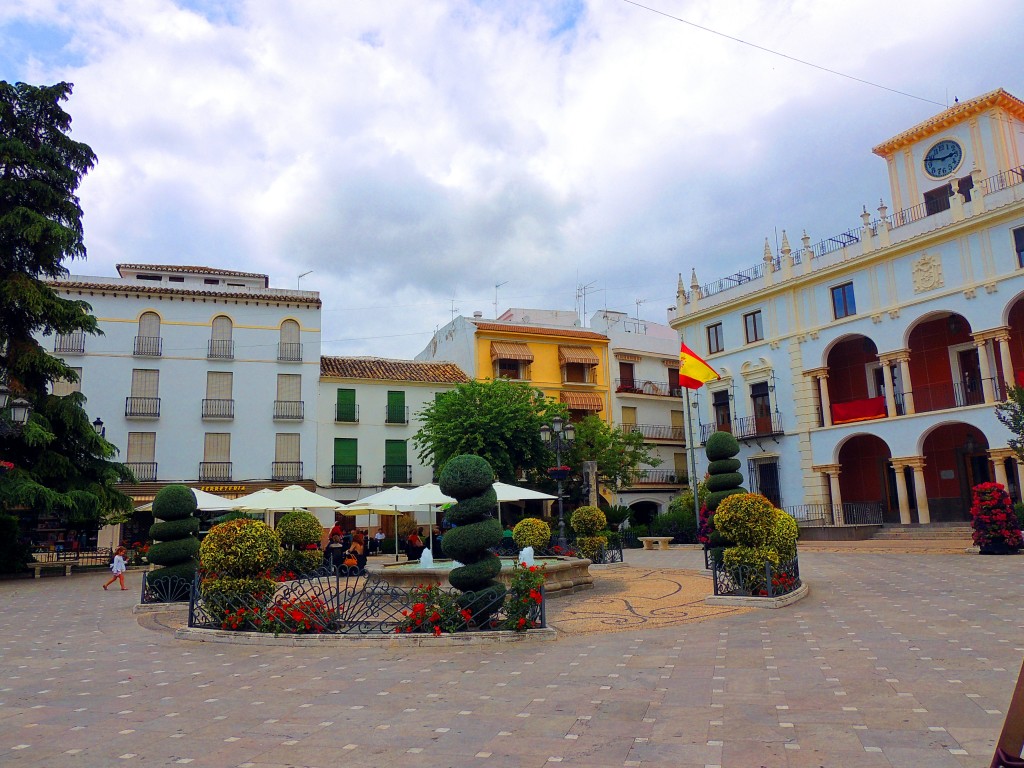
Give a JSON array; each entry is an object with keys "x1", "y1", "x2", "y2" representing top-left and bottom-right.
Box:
[{"x1": 0, "y1": 548, "x2": 1024, "y2": 768}]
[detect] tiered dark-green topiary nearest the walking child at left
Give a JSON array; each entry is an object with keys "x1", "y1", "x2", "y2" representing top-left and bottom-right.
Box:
[{"x1": 146, "y1": 485, "x2": 199, "y2": 585}]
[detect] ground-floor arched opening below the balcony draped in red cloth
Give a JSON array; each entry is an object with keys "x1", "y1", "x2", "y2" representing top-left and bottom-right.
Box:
[{"x1": 839, "y1": 434, "x2": 899, "y2": 523}]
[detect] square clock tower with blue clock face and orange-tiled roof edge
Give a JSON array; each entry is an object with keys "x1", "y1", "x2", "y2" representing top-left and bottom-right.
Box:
[{"x1": 872, "y1": 88, "x2": 1024, "y2": 215}]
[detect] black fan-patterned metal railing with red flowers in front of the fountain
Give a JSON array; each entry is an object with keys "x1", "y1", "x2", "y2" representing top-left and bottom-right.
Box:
[{"x1": 188, "y1": 567, "x2": 547, "y2": 635}]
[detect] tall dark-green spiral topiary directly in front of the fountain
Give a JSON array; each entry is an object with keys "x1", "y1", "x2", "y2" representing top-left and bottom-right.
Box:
[{"x1": 437, "y1": 455, "x2": 505, "y2": 624}]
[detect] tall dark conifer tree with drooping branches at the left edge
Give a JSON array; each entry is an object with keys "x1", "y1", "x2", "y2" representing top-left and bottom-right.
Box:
[{"x1": 0, "y1": 81, "x2": 132, "y2": 525}]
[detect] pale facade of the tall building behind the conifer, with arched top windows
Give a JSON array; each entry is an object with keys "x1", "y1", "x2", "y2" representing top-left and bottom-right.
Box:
[{"x1": 42, "y1": 264, "x2": 321, "y2": 495}]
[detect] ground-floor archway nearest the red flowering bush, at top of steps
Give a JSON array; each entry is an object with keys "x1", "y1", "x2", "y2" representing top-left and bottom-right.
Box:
[{"x1": 922, "y1": 422, "x2": 995, "y2": 522}]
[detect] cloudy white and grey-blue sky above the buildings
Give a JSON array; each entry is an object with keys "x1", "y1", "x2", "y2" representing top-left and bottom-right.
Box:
[{"x1": 0, "y1": 0, "x2": 1024, "y2": 357}]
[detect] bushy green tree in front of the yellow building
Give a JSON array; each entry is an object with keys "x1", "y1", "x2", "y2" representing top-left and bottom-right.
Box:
[{"x1": 413, "y1": 379, "x2": 566, "y2": 482}]
